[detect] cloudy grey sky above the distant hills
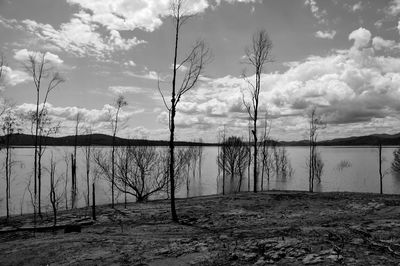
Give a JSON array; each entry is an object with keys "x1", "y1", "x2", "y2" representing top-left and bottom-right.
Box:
[{"x1": 0, "y1": 0, "x2": 400, "y2": 141}]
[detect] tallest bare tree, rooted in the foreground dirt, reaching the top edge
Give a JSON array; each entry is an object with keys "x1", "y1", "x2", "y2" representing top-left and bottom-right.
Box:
[{"x1": 158, "y1": 0, "x2": 210, "y2": 222}]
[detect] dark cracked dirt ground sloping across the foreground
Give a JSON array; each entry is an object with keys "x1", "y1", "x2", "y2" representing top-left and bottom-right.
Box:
[{"x1": 0, "y1": 192, "x2": 400, "y2": 266}]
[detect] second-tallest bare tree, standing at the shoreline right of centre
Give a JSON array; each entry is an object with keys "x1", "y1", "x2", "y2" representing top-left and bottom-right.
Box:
[{"x1": 243, "y1": 30, "x2": 272, "y2": 192}]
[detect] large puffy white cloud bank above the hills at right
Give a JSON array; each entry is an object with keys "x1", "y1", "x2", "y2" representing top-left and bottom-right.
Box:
[{"x1": 158, "y1": 25, "x2": 400, "y2": 139}]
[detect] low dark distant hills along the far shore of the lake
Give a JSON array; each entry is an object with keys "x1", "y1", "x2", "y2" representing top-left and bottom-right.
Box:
[{"x1": 0, "y1": 133, "x2": 400, "y2": 146}]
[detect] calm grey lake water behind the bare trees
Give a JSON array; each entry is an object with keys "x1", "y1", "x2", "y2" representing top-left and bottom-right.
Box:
[{"x1": 0, "y1": 147, "x2": 400, "y2": 215}]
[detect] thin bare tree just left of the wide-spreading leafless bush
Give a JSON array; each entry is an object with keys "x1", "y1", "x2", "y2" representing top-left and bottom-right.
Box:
[{"x1": 110, "y1": 95, "x2": 128, "y2": 208}]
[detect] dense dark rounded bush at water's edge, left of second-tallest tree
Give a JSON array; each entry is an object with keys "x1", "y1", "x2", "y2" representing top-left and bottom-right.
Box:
[{"x1": 217, "y1": 136, "x2": 249, "y2": 191}]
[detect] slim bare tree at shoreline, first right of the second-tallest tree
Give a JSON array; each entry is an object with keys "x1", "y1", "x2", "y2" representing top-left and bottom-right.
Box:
[{"x1": 307, "y1": 106, "x2": 324, "y2": 192}]
